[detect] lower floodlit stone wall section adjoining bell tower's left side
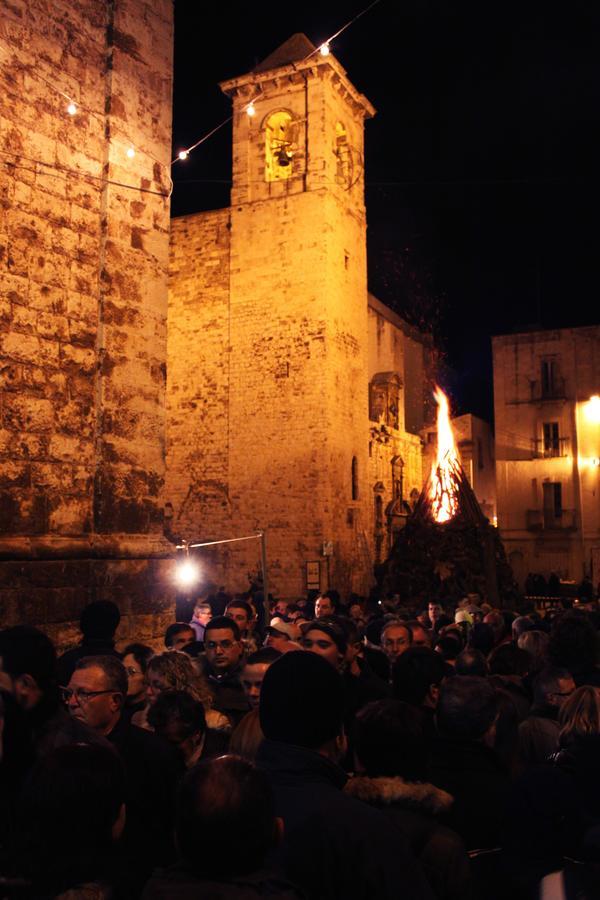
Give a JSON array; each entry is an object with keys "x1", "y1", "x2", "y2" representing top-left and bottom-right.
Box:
[{"x1": 165, "y1": 209, "x2": 235, "y2": 578}]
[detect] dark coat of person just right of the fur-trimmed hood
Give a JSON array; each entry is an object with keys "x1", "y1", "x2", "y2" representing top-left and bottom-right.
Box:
[{"x1": 429, "y1": 738, "x2": 509, "y2": 850}]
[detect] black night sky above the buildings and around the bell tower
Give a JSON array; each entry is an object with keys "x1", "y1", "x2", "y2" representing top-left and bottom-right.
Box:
[{"x1": 172, "y1": 0, "x2": 600, "y2": 420}]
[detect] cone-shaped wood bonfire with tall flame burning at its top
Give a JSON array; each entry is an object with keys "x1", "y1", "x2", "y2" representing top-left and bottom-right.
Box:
[{"x1": 377, "y1": 388, "x2": 514, "y2": 606}]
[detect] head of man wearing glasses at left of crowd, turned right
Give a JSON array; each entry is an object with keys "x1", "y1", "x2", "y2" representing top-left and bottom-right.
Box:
[{"x1": 62, "y1": 656, "x2": 127, "y2": 736}]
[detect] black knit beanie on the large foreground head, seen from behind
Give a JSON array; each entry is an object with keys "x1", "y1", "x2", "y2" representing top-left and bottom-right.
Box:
[{"x1": 259, "y1": 650, "x2": 344, "y2": 750}]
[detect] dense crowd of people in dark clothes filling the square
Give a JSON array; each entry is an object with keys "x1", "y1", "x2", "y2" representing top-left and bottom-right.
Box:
[{"x1": 0, "y1": 591, "x2": 600, "y2": 900}]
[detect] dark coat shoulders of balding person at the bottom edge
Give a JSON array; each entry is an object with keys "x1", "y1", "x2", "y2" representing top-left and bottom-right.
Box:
[{"x1": 142, "y1": 864, "x2": 304, "y2": 900}]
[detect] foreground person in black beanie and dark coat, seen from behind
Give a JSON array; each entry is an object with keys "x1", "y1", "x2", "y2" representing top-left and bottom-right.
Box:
[{"x1": 256, "y1": 651, "x2": 432, "y2": 900}]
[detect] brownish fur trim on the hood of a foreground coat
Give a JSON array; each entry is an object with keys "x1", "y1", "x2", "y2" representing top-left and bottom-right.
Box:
[{"x1": 344, "y1": 775, "x2": 454, "y2": 816}]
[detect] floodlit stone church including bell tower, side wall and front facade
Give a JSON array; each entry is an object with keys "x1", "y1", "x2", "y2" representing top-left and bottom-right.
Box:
[{"x1": 165, "y1": 35, "x2": 432, "y2": 598}]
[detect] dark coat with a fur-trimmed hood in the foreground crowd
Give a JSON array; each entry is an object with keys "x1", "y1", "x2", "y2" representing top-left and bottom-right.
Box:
[{"x1": 345, "y1": 776, "x2": 472, "y2": 900}]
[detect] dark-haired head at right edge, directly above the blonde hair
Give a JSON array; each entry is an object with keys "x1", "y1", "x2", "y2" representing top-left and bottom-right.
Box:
[{"x1": 548, "y1": 611, "x2": 600, "y2": 686}]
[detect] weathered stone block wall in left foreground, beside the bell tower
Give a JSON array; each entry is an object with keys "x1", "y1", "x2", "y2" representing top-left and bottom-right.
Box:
[{"x1": 0, "y1": 0, "x2": 172, "y2": 643}]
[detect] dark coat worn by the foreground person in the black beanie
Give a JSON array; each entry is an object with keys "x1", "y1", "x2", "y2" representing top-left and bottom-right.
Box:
[{"x1": 256, "y1": 740, "x2": 433, "y2": 900}]
